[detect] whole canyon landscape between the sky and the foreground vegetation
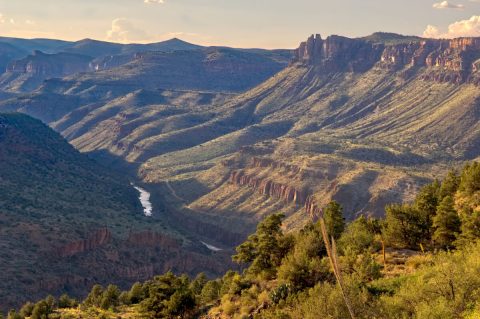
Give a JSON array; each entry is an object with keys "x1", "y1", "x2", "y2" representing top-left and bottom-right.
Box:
[{"x1": 0, "y1": 33, "x2": 480, "y2": 310}]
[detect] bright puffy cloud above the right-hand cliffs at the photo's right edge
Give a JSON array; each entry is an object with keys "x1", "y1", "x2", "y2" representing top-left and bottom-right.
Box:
[{"x1": 423, "y1": 16, "x2": 480, "y2": 38}]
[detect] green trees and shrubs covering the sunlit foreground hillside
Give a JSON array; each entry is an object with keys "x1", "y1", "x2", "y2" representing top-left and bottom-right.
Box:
[{"x1": 3, "y1": 163, "x2": 480, "y2": 319}]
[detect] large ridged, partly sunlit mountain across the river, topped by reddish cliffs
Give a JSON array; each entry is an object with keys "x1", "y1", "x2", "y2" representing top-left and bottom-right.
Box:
[{"x1": 0, "y1": 33, "x2": 480, "y2": 245}]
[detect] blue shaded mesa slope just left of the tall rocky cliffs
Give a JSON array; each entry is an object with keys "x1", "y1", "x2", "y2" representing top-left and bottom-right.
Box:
[{"x1": 54, "y1": 48, "x2": 286, "y2": 92}]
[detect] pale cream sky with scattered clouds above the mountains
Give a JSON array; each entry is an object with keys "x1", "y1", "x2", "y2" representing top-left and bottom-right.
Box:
[{"x1": 0, "y1": 0, "x2": 480, "y2": 49}]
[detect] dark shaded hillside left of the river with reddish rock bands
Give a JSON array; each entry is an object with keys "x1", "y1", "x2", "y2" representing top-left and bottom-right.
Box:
[{"x1": 0, "y1": 113, "x2": 232, "y2": 309}]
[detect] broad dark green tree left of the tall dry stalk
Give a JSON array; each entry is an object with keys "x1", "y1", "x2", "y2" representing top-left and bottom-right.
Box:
[{"x1": 233, "y1": 214, "x2": 289, "y2": 277}]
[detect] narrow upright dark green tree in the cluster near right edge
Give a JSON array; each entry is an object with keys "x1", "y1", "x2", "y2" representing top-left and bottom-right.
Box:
[{"x1": 433, "y1": 196, "x2": 460, "y2": 249}]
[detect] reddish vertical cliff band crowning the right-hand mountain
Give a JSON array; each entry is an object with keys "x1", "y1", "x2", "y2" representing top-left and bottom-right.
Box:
[{"x1": 293, "y1": 34, "x2": 480, "y2": 84}]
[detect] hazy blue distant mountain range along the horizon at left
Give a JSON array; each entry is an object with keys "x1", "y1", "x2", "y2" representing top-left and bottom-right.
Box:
[{"x1": 0, "y1": 38, "x2": 292, "y2": 92}]
